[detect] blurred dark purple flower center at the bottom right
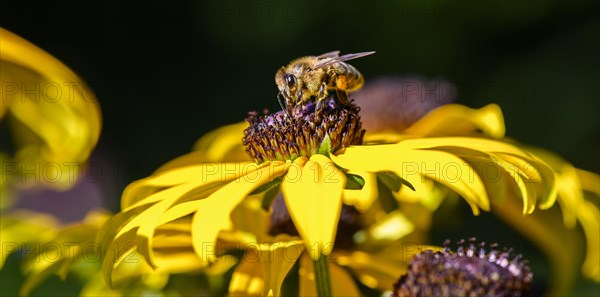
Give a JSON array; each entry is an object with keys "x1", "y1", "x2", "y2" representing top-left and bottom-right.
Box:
[{"x1": 393, "y1": 239, "x2": 533, "y2": 297}]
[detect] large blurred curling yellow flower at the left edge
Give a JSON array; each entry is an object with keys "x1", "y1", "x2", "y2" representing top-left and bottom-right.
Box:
[{"x1": 0, "y1": 28, "x2": 101, "y2": 189}]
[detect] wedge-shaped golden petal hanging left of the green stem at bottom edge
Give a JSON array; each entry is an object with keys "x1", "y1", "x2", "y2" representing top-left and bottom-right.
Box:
[{"x1": 258, "y1": 241, "x2": 304, "y2": 297}]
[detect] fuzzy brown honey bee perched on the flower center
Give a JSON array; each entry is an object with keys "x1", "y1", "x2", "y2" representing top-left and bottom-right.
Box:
[{"x1": 275, "y1": 51, "x2": 375, "y2": 115}]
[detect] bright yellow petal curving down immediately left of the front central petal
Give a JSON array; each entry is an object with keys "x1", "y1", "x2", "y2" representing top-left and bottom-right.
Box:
[{"x1": 192, "y1": 162, "x2": 289, "y2": 263}]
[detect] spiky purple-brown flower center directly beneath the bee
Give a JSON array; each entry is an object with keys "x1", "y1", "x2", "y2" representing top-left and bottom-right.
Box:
[{"x1": 242, "y1": 97, "x2": 365, "y2": 163}]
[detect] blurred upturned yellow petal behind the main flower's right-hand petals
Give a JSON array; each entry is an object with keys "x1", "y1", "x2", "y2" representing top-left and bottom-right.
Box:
[{"x1": 403, "y1": 104, "x2": 505, "y2": 138}]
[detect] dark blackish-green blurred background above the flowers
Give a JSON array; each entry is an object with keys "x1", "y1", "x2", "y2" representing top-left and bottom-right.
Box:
[{"x1": 0, "y1": 0, "x2": 600, "y2": 294}]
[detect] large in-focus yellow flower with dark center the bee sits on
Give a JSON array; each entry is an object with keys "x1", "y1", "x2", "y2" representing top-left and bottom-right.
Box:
[{"x1": 99, "y1": 96, "x2": 556, "y2": 294}]
